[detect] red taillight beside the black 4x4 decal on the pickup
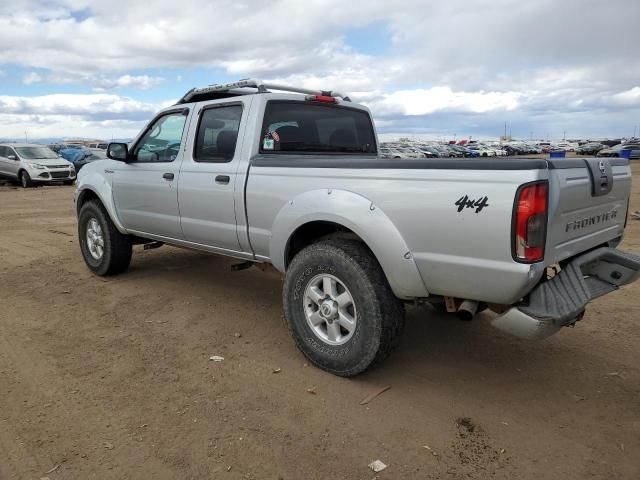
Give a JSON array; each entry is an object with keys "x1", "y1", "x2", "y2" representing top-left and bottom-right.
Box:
[{"x1": 513, "y1": 181, "x2": 549, "y2": 263}]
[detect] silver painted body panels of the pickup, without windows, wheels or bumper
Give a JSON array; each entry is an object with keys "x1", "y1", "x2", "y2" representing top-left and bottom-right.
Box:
[{"x1": 76, "y1": 93, "x2": 631, "y2": 305}]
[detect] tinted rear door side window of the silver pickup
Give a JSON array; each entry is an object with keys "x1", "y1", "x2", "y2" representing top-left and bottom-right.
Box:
[{"x1": 193, "y1": 105, "x2": 242, "y2": 163}]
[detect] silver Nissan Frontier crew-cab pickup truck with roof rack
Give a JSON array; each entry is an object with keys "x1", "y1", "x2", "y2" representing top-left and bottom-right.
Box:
[{"x1": 75, "y1": 80, "x2": 640, "y2": 376}]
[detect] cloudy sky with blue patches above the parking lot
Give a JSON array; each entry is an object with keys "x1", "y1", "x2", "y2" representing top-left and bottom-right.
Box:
[{"x1": 0, "y1": 0, "x2": 640, "y2": 139}]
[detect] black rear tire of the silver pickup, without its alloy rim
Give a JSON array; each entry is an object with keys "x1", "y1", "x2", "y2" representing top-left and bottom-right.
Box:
[{"x1": 283, "y1": 239, "x2": 404, "y2": 377}]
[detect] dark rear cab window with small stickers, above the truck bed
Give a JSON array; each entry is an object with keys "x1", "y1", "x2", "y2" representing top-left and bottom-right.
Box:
[{"x1": 260, "y1": 101, "x2": 377, "y2": 155}]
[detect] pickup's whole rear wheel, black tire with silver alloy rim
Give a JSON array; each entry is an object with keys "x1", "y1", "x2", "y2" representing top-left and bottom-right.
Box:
[{"x1": 283, "y1": 239, "x2": 404, "y2": 377}]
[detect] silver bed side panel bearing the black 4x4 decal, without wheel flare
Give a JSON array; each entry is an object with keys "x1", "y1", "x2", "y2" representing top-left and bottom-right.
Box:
[{"x1": 246, "y1": 162, "x2": 547, "y2": 303}]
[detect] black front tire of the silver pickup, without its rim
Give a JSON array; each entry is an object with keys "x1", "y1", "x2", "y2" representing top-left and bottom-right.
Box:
[{"x1": 78, "y1": 200, "x2": 132, "y2": 276}]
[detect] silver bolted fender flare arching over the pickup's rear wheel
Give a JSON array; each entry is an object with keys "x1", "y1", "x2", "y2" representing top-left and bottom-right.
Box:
[{"x1": 269, "y1": 188, "x2": 429, "y2": 299}]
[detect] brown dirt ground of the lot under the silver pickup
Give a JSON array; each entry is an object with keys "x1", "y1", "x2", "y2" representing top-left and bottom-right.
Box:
[{"x1": 0, "y1": 164, "x2": 640, "y2": 480}]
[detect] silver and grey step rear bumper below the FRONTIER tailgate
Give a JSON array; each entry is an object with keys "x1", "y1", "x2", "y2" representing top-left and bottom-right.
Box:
[{"x1": 491, "y1": 247, "x2": 640, "y2": 339}]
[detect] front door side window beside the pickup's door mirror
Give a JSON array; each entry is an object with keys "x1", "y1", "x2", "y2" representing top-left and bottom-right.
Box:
[{"x1": 133, "y1": 112, "x2": 187, "y2": 163}]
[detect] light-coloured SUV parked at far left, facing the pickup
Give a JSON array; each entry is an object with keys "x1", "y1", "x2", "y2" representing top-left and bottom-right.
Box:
[{"x1": 0, "y1": 143, "x2": 76, "y2": 188}]
